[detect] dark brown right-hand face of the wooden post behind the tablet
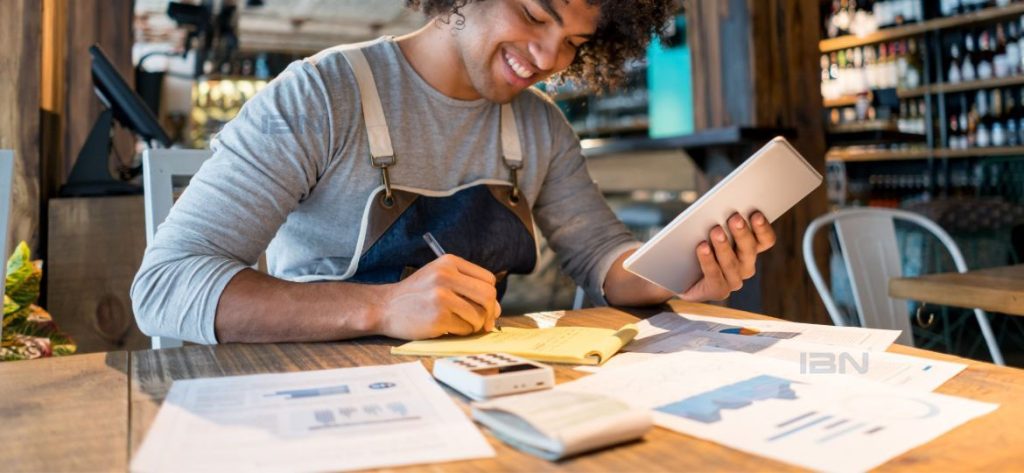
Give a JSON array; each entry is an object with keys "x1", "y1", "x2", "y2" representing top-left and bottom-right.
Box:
[{"x1": 749, "y1": 0, "x2": 828, "y2": 324}]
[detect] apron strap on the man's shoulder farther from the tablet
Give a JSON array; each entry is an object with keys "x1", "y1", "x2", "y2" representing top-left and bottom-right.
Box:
[{"x1": 341, "y1": 48, "x2": 396, "y2": 206}]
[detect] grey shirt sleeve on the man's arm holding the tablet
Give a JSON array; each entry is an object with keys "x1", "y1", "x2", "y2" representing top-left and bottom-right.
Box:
[{"x1": 534, "y1": 105, "x2": 640, "y2": 304}]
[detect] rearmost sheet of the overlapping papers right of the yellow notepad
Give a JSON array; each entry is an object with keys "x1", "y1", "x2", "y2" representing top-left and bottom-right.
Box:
[{"x1": 635, "y1": 312, "x2": 900, "y2": 351}]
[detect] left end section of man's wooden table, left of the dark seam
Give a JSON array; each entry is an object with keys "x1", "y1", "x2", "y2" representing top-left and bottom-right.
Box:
[{"x1": 0, "y1": 351, "x2": 129, "y2": 472}]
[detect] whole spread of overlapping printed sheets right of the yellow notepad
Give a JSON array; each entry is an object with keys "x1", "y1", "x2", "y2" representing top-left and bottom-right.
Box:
[{"x1": 557, "y1": 312, "x2": 997, "y2": 471}]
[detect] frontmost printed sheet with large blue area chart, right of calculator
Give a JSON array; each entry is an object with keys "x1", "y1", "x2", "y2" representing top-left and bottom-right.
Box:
[{"x1": 556, "y1": 351, "x2": 997, "y2": 471}]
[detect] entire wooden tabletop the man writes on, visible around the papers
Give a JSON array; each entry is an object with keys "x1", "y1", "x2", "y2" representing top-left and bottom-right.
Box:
[{"x1": 0, "y1": 302, "x2": 1024, "y2": 471}]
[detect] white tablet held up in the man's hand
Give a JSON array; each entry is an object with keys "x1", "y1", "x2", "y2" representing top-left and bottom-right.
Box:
[{"x1": 623, "y1": 137, "x2": 821, "y2": 294}]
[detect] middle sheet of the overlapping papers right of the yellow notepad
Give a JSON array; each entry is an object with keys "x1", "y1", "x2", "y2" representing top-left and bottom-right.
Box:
[{"x1": 598, "y1": 327, "x2": 967, "y2": 391}]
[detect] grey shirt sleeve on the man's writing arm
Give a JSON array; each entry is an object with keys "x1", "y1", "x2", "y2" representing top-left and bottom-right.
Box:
[{"x1": 131, "y1": 60, "x2": 338, "y2": 344}]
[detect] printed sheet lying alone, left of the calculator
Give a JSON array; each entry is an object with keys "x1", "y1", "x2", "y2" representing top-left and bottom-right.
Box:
[{"x1": 131, "y1": 362, "x2": 495, "y2": 472}]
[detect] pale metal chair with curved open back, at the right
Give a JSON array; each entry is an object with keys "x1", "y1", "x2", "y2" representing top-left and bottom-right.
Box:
[{"x1": 803, "y1": 209, "x2": 1005, "y2": 364}]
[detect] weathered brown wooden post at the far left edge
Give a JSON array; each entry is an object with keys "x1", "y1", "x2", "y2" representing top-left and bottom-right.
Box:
[{"x1": 0, "y1": 0, "x2": 42, "y2": 254}]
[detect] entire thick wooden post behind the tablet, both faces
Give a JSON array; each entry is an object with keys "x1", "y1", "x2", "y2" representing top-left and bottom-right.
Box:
[{"x1": 686, "y1": 0, "x2": 828, "y2": 323}]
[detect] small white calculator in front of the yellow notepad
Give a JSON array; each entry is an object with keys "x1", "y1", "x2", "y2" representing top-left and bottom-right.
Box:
[{"x1": 434, "y1": 353, "x2": 555, "y2": 400}]
